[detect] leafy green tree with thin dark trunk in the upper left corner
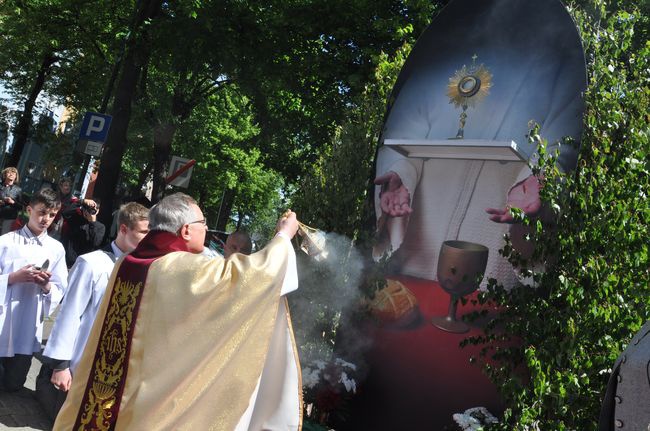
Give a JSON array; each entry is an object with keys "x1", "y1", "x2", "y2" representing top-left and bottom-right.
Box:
[{"x1": 0, "y1": 0, "x2": 134, "y2": 169}]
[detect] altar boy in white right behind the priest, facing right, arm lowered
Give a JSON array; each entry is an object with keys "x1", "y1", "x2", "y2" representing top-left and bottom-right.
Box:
[{"x1": 43, "y1": 202, "x2": 149, "y2": 392}]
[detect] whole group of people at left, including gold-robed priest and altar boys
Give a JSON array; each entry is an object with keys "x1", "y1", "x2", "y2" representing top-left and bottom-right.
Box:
[{"x1": 0, "y1": 174, "x2": 292, "y2": 429}]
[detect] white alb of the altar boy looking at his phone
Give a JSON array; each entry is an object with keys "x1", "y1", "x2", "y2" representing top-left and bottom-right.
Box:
[{"x1": 0, "y1": 226, "x2": 68, "y2": 357}]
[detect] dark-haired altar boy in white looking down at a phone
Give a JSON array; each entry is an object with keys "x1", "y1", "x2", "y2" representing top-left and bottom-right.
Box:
[{"x1": 0, "y1": 189, "x2": 68, "y2": 391}]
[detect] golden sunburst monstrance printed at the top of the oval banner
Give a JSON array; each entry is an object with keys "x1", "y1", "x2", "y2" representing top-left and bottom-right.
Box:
[{"x1": 447, "y1": 54, "x2": 492, "y2": 139}]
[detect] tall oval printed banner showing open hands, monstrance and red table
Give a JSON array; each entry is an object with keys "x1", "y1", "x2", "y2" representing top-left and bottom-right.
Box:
[{"x1": 351, "y1": 0, "x2": 586, "y2": 430}]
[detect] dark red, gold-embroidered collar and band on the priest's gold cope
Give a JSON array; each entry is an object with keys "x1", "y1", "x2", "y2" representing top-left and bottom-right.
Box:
[{"x1": 74, "y1": 231, "x2": 188, "y2": 430}]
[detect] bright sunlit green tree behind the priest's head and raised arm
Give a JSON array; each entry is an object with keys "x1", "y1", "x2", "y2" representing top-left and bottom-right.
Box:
[{"x1": 173, "y1": 87, "x2": 285, "y2": 243}]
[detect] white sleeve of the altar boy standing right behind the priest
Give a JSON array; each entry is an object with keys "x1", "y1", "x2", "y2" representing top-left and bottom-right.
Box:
[{"x1": 43, "y1": 259, "x2": 93, "y2": 360}]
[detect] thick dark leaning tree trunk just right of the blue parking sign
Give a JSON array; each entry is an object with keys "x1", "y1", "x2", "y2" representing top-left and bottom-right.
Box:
[{"x1": 95, "y1": 0, "x2": 162, "y2": 228}]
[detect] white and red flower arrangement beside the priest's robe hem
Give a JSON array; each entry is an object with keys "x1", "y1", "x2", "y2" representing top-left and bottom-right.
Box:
[{"x1": 302, "y1": 358, "x2": 357, "y2": 424}]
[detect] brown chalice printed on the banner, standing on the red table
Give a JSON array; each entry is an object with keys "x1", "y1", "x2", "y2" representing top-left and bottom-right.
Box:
[{"x1": 431, "y1": 241, "x2": 488, "y2": 334}]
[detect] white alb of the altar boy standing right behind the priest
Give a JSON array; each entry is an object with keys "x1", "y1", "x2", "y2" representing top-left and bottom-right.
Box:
[{"x1": 43, "y1": 242, "x2": 124, "y2": 373}]
